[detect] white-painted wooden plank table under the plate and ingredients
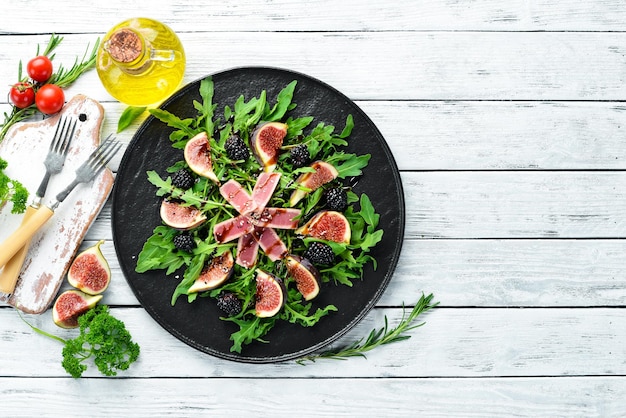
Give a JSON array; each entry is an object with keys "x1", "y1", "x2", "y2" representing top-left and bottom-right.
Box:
[{"x1": 0, "y1": 0, "x2": 626, "y2": 417}]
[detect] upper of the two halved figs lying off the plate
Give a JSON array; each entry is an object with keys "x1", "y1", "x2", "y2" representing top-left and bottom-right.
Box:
[{"x1": 67, "y1": 240, "x2": 111, "y2": 295}]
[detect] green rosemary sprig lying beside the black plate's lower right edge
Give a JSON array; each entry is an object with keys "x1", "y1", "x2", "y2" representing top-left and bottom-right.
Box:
[{"x1": 296, "y1": 293, "x2": 439, "y2": 365}]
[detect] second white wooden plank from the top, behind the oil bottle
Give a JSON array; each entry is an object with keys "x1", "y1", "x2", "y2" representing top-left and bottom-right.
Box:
[{"x1": 0, "y1": 32, "x2": 626, "y2": 101}]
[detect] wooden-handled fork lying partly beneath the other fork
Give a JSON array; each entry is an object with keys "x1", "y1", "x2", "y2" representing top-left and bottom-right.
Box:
[{"x1": 0, "y1": 118, "x2": 76, "y2": 293}]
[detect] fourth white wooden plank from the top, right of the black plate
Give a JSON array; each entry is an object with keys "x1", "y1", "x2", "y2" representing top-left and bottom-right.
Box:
[{"x1": 402, "y1": 171, "x2": 626, "y2": 238}]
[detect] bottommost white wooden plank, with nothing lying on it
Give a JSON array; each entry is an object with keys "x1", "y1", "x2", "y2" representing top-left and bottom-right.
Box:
[{"x1": 0, "y1": 377, "x2": 626, "y2": 418}]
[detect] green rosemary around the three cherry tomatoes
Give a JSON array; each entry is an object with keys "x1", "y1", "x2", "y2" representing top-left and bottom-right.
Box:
[{"x1": 0, "y1": 34, "x2": 100, "y2": 142}]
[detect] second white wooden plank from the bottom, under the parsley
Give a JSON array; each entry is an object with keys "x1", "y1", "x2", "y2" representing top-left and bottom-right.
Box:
[{"x1": 0, "y1": 306, "x2": 626, "y2": 378}]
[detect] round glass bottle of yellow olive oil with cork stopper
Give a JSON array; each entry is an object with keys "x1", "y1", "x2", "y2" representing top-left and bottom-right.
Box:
[{"x1": 96, "y1": 17, "x2": 185, "y2": 106}]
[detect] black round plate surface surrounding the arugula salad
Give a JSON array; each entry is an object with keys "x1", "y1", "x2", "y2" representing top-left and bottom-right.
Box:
[{"x1": 112, "y1": 67, "x2": 405, "y2": 363}]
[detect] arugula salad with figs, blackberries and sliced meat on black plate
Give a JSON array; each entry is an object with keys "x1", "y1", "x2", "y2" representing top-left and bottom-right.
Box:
[{"x1": 135, "y1": 77, "x2": 383, "y2": 353}]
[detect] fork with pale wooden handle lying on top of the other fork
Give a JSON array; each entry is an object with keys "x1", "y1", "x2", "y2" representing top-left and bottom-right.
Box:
[{"x1": 0, "y1": 135, "x2": 122, "y2": 267}]
